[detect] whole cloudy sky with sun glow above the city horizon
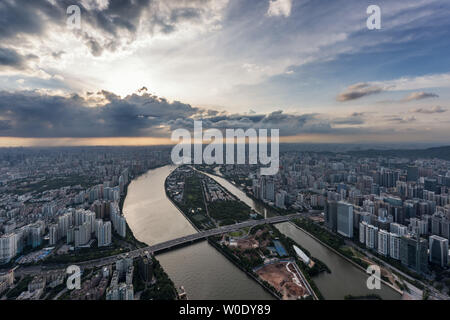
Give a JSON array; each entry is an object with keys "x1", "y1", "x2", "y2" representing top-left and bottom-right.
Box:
[{"x1": 0, "y1": 0, "x2": 450, "y2": 146}]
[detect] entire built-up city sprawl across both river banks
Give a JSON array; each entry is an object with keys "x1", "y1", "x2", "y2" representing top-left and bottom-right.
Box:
[{"x1": 0, "y1": 147, "x2": 450, "y2": 300}]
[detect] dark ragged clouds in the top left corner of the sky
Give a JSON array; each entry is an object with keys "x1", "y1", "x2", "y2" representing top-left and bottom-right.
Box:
[{"x1": 0, "y1": 0, "x2": 216, "y2": 56}]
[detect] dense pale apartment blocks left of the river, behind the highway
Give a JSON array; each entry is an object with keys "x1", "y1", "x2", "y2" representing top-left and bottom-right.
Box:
[{"x1": 0, "y1": 147, "x2": 168, "y2": 264}]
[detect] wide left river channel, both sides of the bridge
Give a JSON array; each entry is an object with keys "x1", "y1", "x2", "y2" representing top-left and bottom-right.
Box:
[{"x1": 123, "y1": 166, "x2": 273, "y2": 300}]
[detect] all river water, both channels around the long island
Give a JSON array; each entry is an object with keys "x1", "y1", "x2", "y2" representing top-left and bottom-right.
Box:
[{"x1": 124, "y1": 166, "x2": 400, "y2": 300}]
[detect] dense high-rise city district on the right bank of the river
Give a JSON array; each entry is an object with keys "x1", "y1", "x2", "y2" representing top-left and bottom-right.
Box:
[{"x1": 222, "y1": 152, "x2": 450, "y2": 273}]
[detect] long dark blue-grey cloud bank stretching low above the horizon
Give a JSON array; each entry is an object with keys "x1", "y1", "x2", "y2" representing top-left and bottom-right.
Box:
[{"x1": 0, "y1": 89, "x2": 372, "y2": 138}]
